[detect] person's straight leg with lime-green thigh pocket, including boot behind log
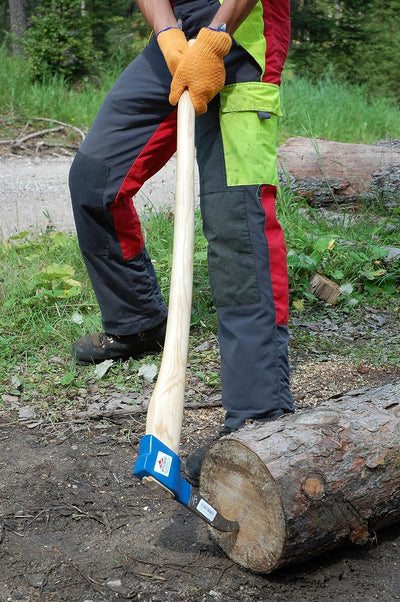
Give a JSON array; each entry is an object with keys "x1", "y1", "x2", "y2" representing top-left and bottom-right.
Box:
[{"x1": 185, "y1": 52, "x2": 294, "y2": 478}]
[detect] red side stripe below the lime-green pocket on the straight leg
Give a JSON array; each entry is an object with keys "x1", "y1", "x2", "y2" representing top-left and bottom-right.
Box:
[{"x1": 261, "y1": 184, "x2": 289, "y2": 326}]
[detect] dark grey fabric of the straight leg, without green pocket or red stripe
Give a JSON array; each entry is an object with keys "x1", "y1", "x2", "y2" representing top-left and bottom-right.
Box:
[{"x1": 196, "y1": 98, "x2": 293, "y2": 428}]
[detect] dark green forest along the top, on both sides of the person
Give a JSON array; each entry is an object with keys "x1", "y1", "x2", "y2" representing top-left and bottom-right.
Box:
[{"x1": 0, "y1": 0, "x2": 400, "y2": 101}]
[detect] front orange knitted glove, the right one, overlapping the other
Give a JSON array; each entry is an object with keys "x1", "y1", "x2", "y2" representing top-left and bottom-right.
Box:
[{"x1": 169, "y1": 27, "x2": 232, "y2": 115}]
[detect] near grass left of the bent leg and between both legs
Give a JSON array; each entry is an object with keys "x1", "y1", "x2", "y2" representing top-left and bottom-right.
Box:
[{"x1": 0, "y1": 210, "x2": 219, "y2": 412}]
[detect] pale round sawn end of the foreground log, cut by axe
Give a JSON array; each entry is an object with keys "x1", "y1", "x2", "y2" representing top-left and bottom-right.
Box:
[{"x1": 200, "y1": 440, "x2": 286, "y2": 573}]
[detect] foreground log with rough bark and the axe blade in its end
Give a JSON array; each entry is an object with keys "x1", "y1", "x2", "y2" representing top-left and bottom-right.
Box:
[{"x1": 200, "y1": 382, "x2": 400, "y2": 573}]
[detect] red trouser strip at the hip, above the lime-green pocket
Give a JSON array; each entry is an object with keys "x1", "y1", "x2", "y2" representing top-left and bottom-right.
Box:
[{"x1": 262, "y1": 0, "x2": 290, "y2": 86}]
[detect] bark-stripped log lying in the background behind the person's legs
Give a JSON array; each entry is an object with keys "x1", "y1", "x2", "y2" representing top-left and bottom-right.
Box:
[{"x1": 278, "y1": 136, "x2": 400, "y2": 206}]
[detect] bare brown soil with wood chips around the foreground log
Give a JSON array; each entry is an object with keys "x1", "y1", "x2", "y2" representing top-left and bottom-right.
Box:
[{"x1": 0, "y1": 151, "x2": 400, "y2": 602}]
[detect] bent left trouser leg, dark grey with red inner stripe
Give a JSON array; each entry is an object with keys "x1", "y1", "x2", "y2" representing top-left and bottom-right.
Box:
[{"x1": 70, "y1": 40, "x2": 176, "y2": 346}]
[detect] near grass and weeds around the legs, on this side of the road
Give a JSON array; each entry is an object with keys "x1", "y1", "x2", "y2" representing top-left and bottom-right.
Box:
[{"x1": 0, "y1": 197, "x2": 400, "y2": 416}]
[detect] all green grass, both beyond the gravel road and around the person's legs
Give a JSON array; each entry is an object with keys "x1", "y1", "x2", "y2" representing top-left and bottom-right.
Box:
[{"x1": 0, "y1": 49, "x2": 400, "y2": 419}]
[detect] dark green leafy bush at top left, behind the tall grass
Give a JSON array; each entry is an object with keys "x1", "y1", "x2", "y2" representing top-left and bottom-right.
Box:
[{"x1": 14, "y1": 0, "x2": 150, "y2": 83}]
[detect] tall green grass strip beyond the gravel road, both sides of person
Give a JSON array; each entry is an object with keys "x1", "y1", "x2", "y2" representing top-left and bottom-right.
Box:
[{"x1": 0, "y1": 47, "x2": 400, "y2": 144}]
